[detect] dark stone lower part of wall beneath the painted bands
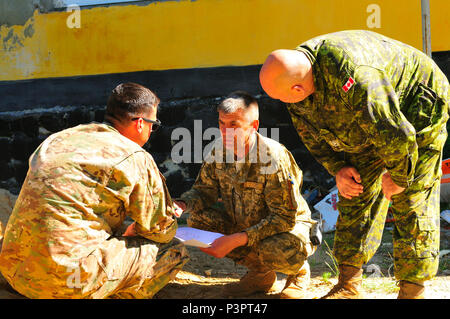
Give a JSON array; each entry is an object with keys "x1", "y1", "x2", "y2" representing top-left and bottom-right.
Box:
[{"x1": 0, "y1": 96, "x2": 334, "y2": 197}]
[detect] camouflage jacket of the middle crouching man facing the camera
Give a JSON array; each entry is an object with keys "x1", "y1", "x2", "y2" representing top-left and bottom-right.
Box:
[{"x1": 181, "y1": 133, "x2": 315, "y2": 246}]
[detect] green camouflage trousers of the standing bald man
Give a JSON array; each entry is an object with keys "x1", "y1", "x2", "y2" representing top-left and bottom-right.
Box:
[{"x1": 334, "y1": 141, "x2": 446, "y2": 283}]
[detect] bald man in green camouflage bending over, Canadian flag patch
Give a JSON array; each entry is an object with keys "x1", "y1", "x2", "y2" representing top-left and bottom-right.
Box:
[{"x1": 260, "y1": 31, "x2": 449, "y2": 298}]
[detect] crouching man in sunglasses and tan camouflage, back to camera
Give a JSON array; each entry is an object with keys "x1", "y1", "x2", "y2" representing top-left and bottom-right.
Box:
[{"x1": 0, "y1": 83, "x2": 188, "y2": 298}]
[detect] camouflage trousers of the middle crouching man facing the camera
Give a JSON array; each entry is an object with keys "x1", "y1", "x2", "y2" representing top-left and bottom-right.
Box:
[{"x1": 187, "y1": 204, "x2": 315, "y2": 275}]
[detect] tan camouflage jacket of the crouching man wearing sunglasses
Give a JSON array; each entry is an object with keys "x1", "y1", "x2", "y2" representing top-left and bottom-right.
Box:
[{"x1": 0, "y1": 123, "x2": 177, "y2": 284}]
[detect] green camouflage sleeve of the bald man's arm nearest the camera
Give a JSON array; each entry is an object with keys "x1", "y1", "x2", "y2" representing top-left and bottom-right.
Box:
[{"x1": 349, "y1": 66, "x2": 418, "y2": 188}]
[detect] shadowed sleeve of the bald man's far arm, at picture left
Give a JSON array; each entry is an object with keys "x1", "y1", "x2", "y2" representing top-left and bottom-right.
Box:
[{"x1": 289, "y1": 108, "x2": 347, "y2": 176}]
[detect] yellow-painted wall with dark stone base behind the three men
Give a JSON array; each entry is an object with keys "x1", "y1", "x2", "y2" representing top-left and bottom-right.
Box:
[{"x1": 0, "y1": 0, "x2": 450, "y2": 200}]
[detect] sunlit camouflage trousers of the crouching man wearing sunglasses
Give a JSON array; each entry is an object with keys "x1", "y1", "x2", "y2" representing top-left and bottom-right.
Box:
[{"x1": 81, "y1": 237, "x2": 189, "y2": 299}]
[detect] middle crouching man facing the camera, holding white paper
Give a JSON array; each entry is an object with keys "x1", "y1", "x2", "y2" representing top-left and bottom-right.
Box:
[{"x1": 177, "y1": 91, "x2": 315, "y2": 298}]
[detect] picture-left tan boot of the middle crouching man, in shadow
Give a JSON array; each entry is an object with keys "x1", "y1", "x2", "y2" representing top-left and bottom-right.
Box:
[{"x1": 224, "y1": 270, "x2": 277, "y2": 297}]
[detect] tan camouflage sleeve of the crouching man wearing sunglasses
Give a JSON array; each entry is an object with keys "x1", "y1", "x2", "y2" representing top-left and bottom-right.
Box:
[{"x1": 109, "y1": 152, "x2": 177, "y2": 243}]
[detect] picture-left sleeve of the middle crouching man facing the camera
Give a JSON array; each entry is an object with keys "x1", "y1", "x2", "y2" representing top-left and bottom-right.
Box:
[{"x1": 180, "y1": 162, "x2": 219, "y2": 212}]
